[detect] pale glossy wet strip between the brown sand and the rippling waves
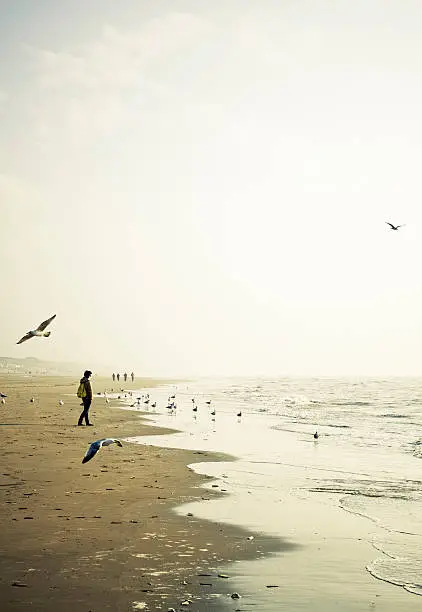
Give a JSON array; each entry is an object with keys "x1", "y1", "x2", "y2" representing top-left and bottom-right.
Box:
[{"x1": 123, "y1": 386, "x2": 420, "y2": 612}]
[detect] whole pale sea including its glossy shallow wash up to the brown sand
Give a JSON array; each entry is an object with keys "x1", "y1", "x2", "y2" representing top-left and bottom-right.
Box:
[{"x1": 125, "y1": 379, "x2": 422, "y2": 612}]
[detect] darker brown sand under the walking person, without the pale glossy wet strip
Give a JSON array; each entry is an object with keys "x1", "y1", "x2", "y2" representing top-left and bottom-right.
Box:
[{"x1": 0, "y1": 375, "x2": 282, "y2": 612}]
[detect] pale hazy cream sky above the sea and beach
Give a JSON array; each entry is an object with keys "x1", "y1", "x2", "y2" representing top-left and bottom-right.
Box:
[{"x1": 0, "y1": 0, "x2": 422, "y2": 377}]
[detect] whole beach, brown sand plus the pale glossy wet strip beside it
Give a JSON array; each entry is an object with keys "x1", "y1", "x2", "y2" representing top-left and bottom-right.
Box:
[{"x1": 0, "y1": 375, "x2": 420, "y2": 612}]
